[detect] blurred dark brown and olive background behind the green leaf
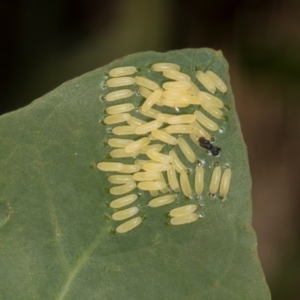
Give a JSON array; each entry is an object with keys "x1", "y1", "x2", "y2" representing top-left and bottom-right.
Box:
[{"x1": 0, "y1": 0, "x2": 300, "y2": 300}]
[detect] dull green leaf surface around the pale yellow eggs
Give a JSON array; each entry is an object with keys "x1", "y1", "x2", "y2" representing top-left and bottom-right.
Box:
[{"x1": 0, "y1": 49, "x2": 270, "y2": 300}]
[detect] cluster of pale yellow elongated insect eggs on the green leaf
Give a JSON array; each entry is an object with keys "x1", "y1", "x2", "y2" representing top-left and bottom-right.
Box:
[{"x1": 97, "y1": 63, "x2": 231, "y2": 233}]
